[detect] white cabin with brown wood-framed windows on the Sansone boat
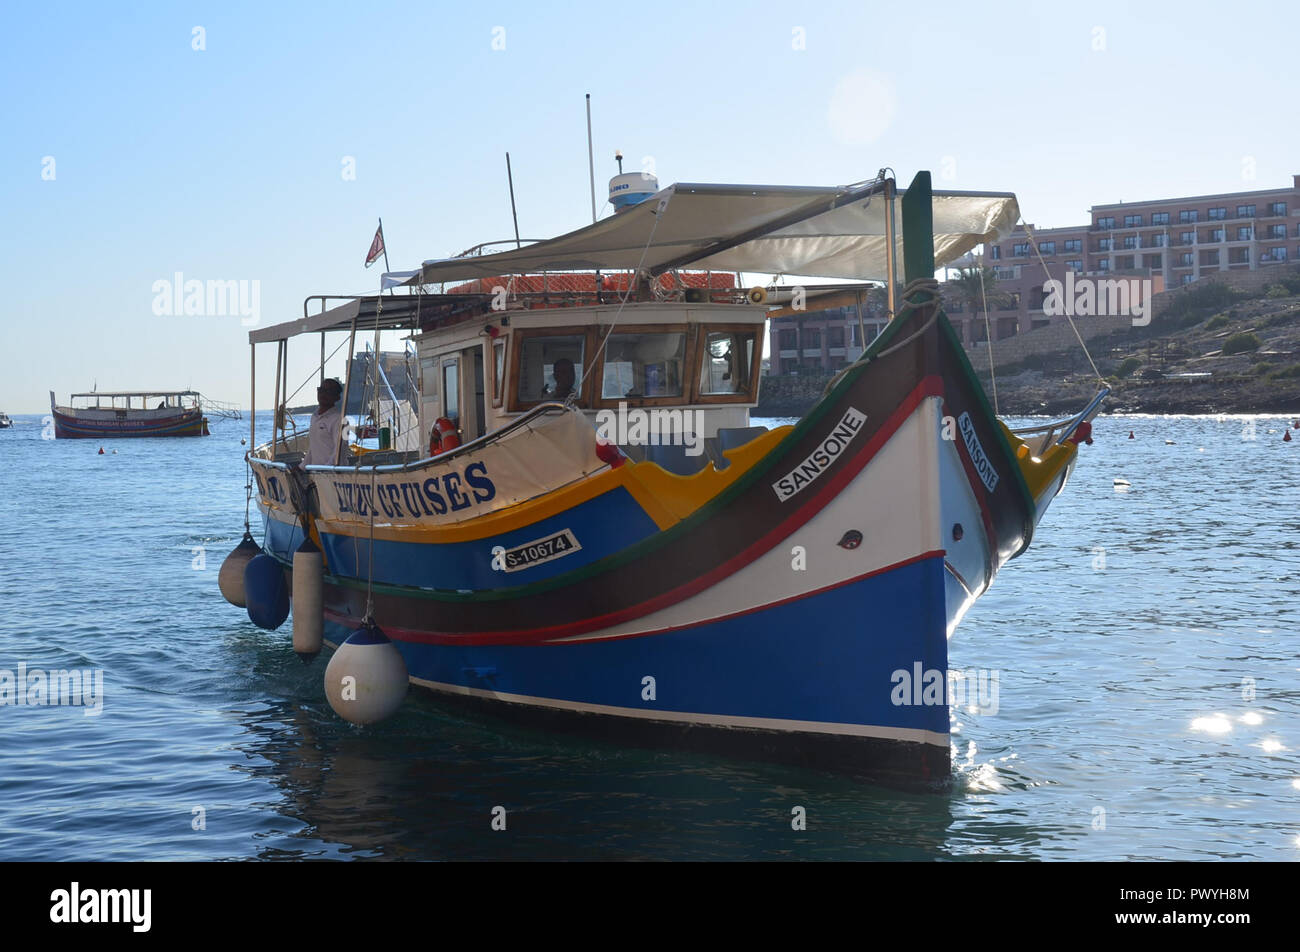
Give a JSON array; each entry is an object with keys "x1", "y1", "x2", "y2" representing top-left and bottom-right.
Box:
[{"x1": 413, "y1": 288, "x2": 766, "y2": 462}]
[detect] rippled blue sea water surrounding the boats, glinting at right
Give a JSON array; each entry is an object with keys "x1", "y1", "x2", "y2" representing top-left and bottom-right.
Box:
[{"x1": 0, "y1": 416, "x2": 1300, "y2": 860}]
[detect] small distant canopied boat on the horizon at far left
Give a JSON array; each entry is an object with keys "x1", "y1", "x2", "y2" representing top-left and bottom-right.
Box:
[{"x1": 49, "y1": 390, "x2": 208, "y2": 440}]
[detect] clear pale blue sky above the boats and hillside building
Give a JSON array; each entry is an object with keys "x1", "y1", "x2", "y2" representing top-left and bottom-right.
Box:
[{"x1": 0, "y1": 0, "x2": 1300, "y2": 414}]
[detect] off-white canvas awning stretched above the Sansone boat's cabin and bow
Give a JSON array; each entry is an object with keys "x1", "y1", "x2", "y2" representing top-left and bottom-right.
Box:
[{"x1": 408, "y1": 183, "x2": 1021, "y2": 285}]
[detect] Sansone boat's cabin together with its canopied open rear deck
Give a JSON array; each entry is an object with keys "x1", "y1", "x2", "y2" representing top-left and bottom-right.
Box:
[{"x1": 250, "y1": 273, "x2": 767, "y2": 473}]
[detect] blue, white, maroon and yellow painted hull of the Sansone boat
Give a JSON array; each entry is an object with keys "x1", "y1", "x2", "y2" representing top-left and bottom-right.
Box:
[{"x1": 254, "y1": 299, "x2": 1076, "y2": 776}]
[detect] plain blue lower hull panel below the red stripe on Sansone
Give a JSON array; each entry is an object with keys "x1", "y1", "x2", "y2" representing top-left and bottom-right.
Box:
[{"x1": 319, "y1": 557, "x2": 949, "y2": 754}]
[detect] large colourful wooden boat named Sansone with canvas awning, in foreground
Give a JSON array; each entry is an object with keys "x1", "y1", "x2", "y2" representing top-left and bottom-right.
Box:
[{"x1": 236, "y1": 173, "x2": 1104, "y2": 776}]
